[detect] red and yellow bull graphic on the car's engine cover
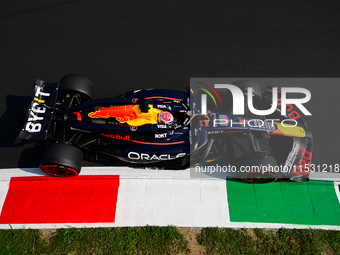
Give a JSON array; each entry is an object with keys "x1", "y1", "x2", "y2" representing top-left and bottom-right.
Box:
[{"x1": 88, "y1": 105, "x2": 171, "y2": 126}]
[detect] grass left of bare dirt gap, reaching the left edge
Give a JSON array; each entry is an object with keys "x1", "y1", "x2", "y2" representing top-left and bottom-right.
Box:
[{"x1": 0, "y1": 226, "x2": 190, "y2": 255}]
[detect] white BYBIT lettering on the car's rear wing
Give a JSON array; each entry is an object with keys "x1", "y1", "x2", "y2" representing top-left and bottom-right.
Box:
[{"x1": 25, "y1": 87, "x2": 50, "y2": 133}]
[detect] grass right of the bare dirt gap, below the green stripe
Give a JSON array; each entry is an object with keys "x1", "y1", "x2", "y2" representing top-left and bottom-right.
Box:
[{"x1": 197, "y1": 228, "x2": 340, "y2": 254}]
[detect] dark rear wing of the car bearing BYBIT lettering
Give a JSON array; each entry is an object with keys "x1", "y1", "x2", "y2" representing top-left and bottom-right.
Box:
[{"x1": 19, "y1": 79, "x2": 59, "y2": 141}]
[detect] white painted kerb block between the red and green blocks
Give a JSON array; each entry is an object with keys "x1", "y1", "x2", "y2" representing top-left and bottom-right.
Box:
[{"x1": 116, "y1": 178, "x2": 230, "y2": 227}]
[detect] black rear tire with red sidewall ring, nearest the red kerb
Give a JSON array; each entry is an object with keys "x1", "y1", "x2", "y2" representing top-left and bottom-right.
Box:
[{"x1": 39, "y1": 143, "x2": 83, "y2": 177}]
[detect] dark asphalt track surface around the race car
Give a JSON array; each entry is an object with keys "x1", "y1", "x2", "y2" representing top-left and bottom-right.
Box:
[{"x1": 0, "y1": 0, "x2": 340, "y2": 175}]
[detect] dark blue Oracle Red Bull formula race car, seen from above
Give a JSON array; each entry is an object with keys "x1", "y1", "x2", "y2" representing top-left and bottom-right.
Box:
[{"x1": 20, "y1": 74, "x2": 312, "y2": 183}]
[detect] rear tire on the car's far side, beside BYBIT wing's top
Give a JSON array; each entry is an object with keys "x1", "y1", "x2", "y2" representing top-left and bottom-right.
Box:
[{"x1": 59, "y1": 74, "x2": 94, "y2": 100}]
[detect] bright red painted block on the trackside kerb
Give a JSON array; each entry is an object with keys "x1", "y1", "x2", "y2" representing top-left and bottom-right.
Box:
[{"x1": 0, "y1": 175, "x2": 119, "y2": 224}]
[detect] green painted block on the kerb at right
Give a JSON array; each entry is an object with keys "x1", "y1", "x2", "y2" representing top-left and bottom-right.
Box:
[{"x1": 227, "y1": 180, "x2": 340, "y2": 225}]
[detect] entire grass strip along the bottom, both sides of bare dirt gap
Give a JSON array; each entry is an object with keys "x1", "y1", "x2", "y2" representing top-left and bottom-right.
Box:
[{"x1": 0, "y1": 226, "x2": 340, "y2": 255}]
